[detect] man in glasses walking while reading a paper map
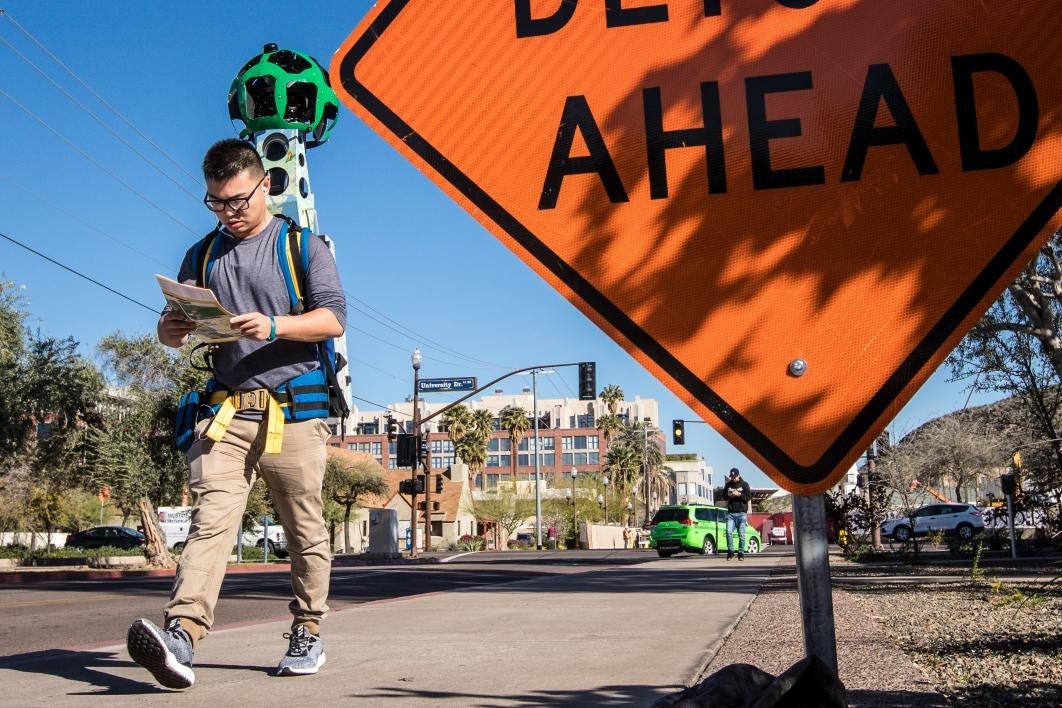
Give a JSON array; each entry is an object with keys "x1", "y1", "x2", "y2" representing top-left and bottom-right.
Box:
[{"x1": 126, "y1": 138, "x2": 346, "y2": 689}]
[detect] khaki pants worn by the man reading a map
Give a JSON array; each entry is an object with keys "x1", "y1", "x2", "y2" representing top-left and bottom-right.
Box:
[{"x1": 166, "y1": 418, "x2": 331, "y2": 639}]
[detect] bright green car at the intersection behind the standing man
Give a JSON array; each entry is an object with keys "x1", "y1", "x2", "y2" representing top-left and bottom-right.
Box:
[{"x1": 649, "y1": 504, "x2": 764, "y2": 558}]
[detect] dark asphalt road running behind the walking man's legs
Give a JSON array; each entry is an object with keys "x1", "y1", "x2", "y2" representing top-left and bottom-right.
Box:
[{"x1": 0, "y1": 551, "x2": 656, "y2": 657}]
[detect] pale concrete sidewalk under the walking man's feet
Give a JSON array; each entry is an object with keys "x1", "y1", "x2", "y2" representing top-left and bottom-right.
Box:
[{"x1": 0, "y1": 554, "x2": 785, "y2": 708}]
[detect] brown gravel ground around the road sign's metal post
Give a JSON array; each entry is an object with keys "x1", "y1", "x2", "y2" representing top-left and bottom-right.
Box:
[{"x1": 679, "y1": 556, "x2": 1062, "y2": 708}]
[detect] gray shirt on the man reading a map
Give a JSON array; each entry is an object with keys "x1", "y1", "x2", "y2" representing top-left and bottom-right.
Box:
[{"x1": 177, "y1": 217, "x2": 346, "y2": 391}]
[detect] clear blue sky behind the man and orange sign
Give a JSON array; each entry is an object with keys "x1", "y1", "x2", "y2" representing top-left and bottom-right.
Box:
[{"x1": 0, "y1": 0, "x2": 998, "y2": 485}]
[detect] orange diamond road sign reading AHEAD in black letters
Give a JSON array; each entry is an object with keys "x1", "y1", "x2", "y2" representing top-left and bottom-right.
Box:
[{"x1": 331, "y1": 0, "x2": 1062, "y2": 494}]
